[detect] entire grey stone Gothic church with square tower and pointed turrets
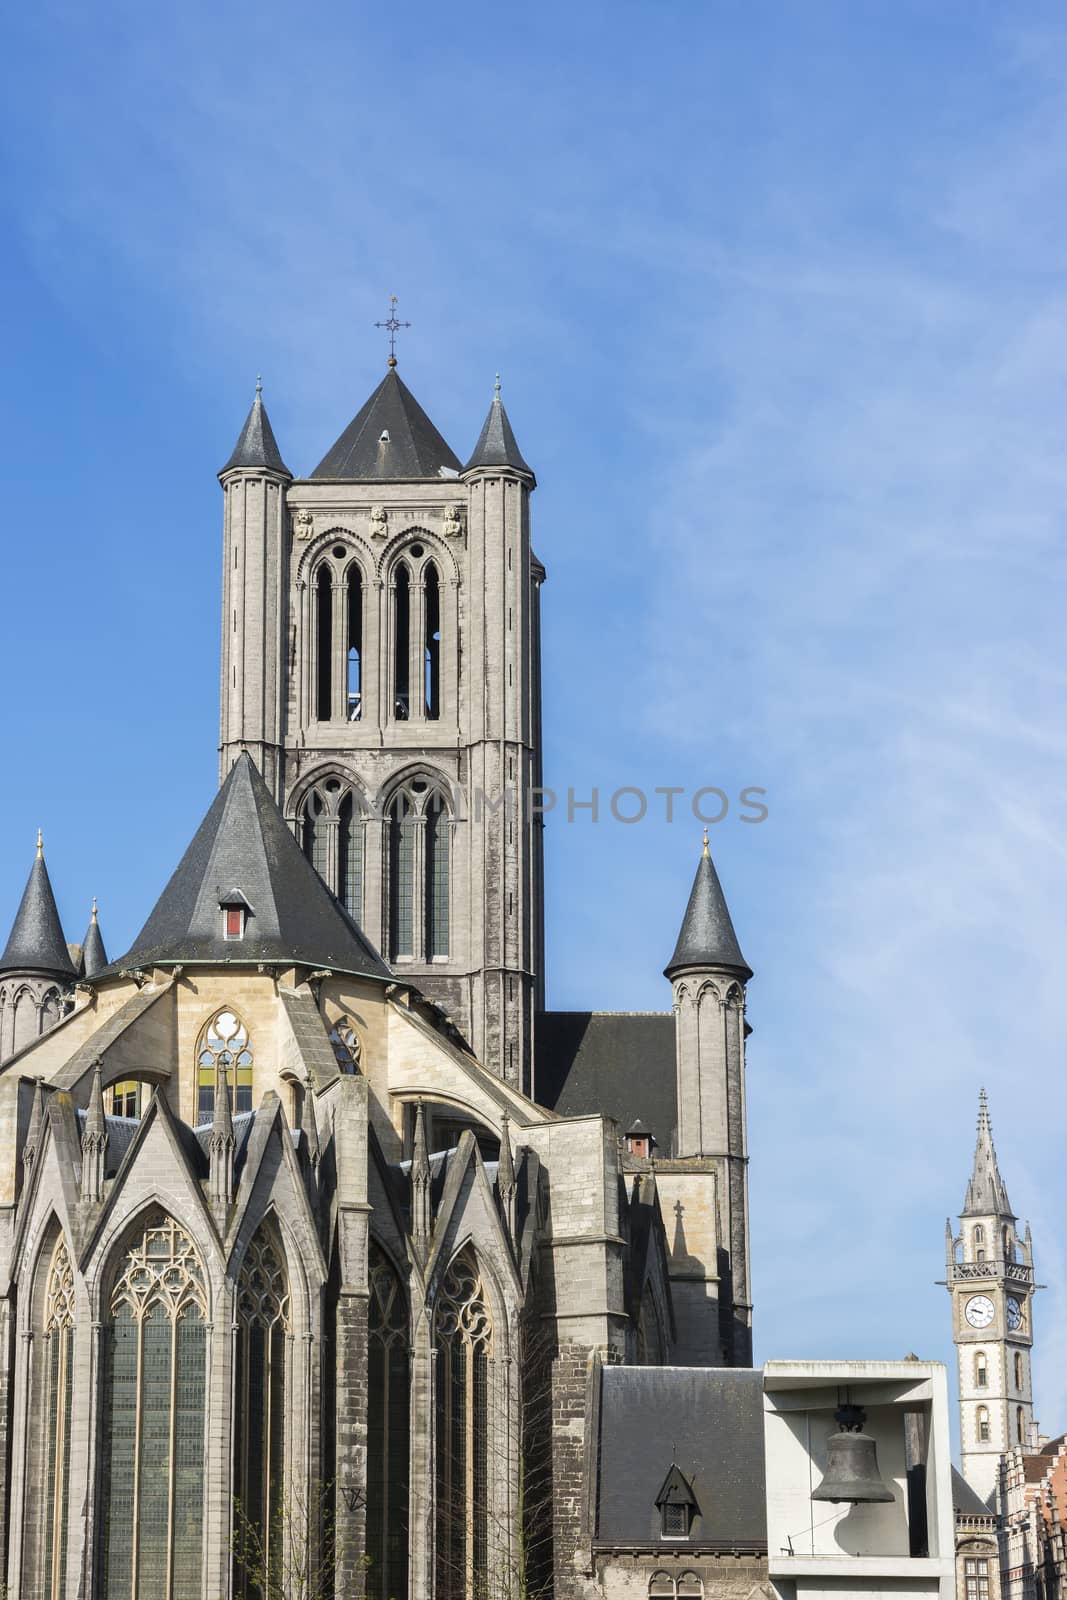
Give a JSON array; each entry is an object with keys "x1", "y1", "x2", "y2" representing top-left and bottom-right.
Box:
[{"x1": 0, "y1": 365, "x2": 766, "y2": 1600}]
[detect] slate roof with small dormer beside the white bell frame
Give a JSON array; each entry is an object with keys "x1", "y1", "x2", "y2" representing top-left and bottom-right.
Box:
[{"x1": 597, "y1": 1366, "x2": 766, "y2": 1552}]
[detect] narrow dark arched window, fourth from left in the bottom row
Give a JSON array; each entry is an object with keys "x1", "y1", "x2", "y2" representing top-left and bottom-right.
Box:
[{"x1": 366, "y1": 1243, "x2": 411, "y2": 1600}]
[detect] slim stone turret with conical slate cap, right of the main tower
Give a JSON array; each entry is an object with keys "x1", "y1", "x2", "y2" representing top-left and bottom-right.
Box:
[{"x1": 664, "y1": 829, "x2": 752, "y2": 1366}]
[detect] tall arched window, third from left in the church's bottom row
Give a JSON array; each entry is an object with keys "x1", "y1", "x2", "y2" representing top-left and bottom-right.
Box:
[{"x1": 234, "y1": 1227, "x2": 290, "y2": 1600}]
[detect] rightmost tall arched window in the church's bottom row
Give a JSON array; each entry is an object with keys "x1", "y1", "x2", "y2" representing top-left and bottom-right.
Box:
[{"x1": 434, "y1": 1251, "x2": 493, "y2": 1600}]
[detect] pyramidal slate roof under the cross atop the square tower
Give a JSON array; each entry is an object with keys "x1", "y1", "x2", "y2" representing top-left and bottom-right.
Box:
[{"x1": 312, "y1": 368, "x2": 459, "y2": 480}]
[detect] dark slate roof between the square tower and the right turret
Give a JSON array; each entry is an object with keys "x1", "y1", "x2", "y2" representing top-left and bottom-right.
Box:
[{"x1": 534, "y1": 1011, "x2": 678, "y2": 1155}]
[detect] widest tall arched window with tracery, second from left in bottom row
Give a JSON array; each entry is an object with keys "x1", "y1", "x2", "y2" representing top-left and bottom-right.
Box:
[{"x1": 101, "y1": 1211, "x2": 208, "y2": 1600}]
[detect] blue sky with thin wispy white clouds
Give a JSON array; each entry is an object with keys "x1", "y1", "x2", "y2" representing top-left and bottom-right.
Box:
[{"x1": 0, "y1": 0, "x2": 1067, "y2": 1432}]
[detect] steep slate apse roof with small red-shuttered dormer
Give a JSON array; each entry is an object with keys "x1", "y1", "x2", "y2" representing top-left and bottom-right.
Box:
[{"x1": 99, "y1": 752, "x2": 392, "y2": 979}]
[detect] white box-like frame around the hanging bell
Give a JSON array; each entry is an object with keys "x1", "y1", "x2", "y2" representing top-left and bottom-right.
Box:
[{"x1": 763, "y1": 1360, "x2": 955, "y2": 1600}]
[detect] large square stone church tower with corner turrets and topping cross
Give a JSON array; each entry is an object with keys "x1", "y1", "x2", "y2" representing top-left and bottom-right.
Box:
[{"x1": 219, "y1": 352, "x2": 544, "y2": 1091}]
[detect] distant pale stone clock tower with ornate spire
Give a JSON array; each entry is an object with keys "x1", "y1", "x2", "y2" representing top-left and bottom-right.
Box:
[{"x1": 945, "y1": 1090, "x2": 1037, "y2": 1504}]
